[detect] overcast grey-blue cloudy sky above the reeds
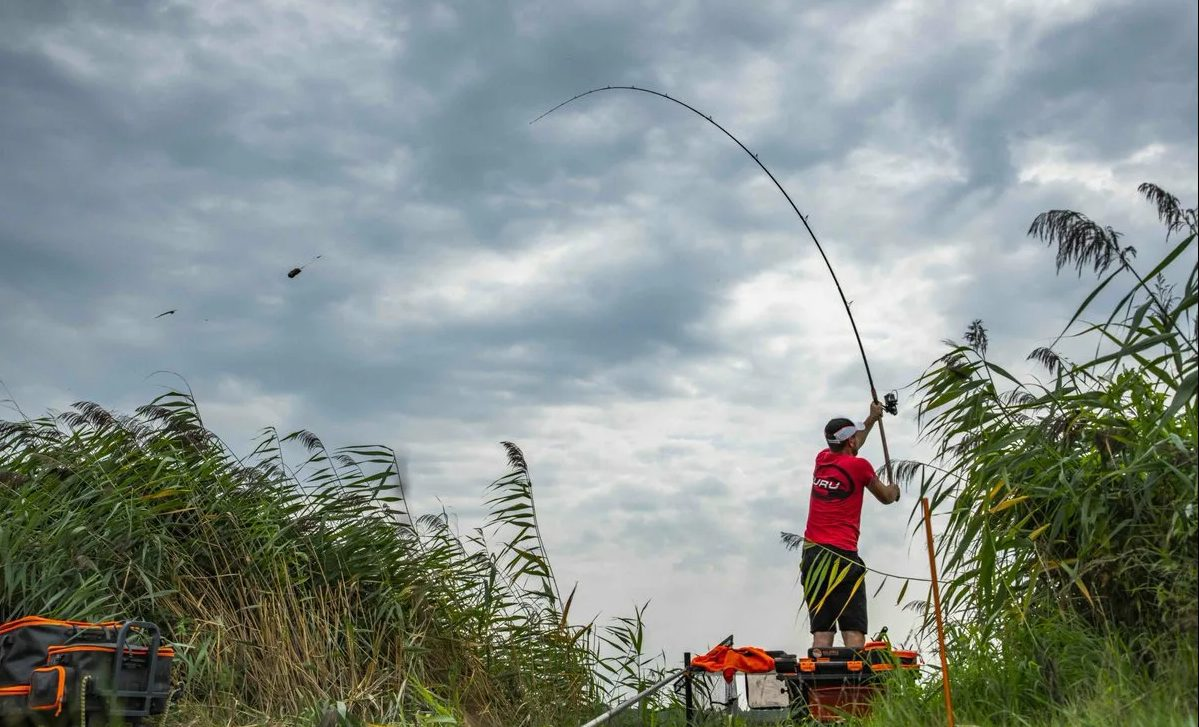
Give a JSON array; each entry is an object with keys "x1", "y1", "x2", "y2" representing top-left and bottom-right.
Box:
[{"x1": 0, "y1": 0, "x2": 1199, "y2": 671}]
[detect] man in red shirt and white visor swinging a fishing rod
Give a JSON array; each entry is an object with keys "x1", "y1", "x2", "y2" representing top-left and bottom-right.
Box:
[{"x1": 800, "y1": 402, "x2": 899, "y2": 648}]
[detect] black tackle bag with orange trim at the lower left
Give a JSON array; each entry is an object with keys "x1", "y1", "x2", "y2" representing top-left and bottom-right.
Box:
[{"x1": 0, "y1": 617, "x2": 175, "y2": 727}]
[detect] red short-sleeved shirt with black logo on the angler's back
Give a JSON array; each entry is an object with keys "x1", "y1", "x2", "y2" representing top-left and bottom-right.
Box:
[{"x1": 803, "y1": 450, "x2": 874, "y2": 551}]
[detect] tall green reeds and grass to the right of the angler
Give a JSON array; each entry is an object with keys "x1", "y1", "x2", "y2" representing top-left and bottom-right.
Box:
[{"x1": 893, "y1": 185, "x2": 1199, "y2": 725}]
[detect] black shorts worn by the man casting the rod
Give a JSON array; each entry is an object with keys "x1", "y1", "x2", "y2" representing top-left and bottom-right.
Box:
[{"x1": 800, "y1": 543, "x2": 867, "y2": 633}]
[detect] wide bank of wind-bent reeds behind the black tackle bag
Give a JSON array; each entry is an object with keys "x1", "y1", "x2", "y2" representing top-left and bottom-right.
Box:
[{"x1": 0, "y1": 392, "x2": 605, "y2": 726}]
